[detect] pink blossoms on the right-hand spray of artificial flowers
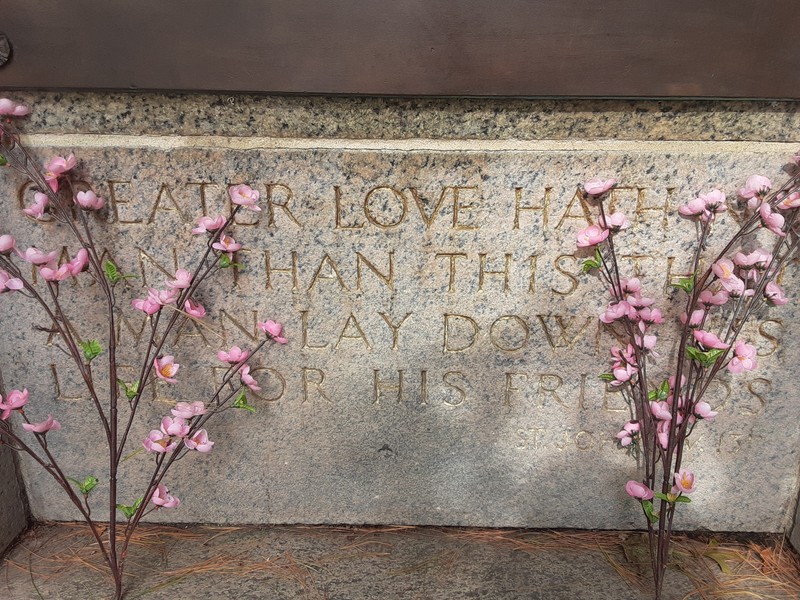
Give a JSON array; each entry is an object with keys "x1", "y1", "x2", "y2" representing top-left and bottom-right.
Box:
[{"x1": 577, "y1": 171, "x2": 800, "y2": 502}]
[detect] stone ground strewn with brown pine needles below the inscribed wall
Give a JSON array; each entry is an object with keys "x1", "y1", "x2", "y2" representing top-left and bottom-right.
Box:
[{"x1": 0, "y1": 524, "x2": 800, "y2": 600}]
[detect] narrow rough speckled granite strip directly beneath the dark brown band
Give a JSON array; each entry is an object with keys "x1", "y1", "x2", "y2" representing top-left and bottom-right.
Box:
[{"x1": 9, "y1": 92, "x2": 800, "y2": 142}]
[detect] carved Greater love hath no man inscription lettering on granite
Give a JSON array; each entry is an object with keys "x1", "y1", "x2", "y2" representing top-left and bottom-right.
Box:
[{"x1": 37, "y1": 175, "x2": 783, "y2": 454}]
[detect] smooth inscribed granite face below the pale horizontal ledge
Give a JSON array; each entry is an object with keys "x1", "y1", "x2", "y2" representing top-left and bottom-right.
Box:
[{"x1": 0, "y1": 139, "x2": 800, "y2": 531}]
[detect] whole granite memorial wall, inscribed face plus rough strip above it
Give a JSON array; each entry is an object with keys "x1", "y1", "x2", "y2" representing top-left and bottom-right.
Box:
[{"x1": 0, "y1": 94, "x2": 800, "y2": 544}]
